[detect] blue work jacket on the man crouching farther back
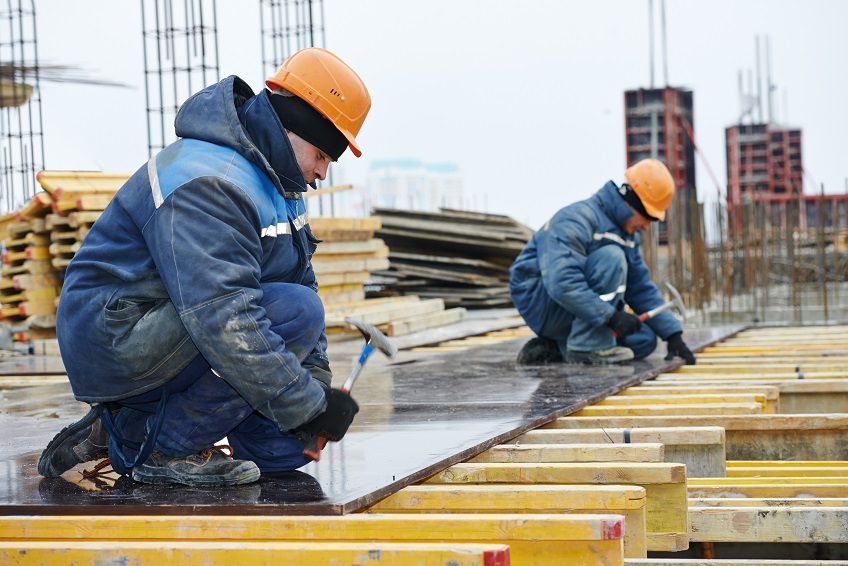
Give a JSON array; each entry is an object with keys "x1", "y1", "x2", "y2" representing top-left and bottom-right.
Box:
[{"x1": 510, "y1": 181, "x2": 681, "y2": 339}]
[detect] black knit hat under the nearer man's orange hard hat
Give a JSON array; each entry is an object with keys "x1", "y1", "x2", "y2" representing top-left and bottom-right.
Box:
[{"x1": 268, "y1": 93, "x2": 348, "y2": 161}]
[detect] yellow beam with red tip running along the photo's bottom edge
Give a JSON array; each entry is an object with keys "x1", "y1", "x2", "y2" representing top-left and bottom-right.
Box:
[{"x1": 0, "y1": 541, "x2": 510, "y2": 566}]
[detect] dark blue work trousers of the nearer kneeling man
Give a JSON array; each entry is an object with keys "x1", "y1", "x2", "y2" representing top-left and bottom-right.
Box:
[{"x1": 109, "y1": 283, "x2": 324, "y2": 473}]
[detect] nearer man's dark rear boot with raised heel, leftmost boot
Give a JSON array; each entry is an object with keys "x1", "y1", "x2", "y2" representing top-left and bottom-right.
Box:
[{"x1": 38, "y1": 407, "x2": 109, "y2": 478}]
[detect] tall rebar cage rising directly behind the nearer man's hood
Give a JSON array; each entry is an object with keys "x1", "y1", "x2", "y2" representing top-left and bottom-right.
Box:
[{"x1": 141, "y1": 0, "x2": 219, "y2": 156}]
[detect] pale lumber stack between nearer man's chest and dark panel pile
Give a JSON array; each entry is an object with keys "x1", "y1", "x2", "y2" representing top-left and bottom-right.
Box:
[{"x1": 309, "y1": 216, "x2": 466, "y2": 336}]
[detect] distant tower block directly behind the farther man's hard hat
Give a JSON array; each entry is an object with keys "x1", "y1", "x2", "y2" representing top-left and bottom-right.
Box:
[{"x1": 624, "y1": 87, "x2": 697, "y2": 243}]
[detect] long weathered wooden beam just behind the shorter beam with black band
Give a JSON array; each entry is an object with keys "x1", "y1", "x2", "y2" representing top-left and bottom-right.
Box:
[{"x1": 544, "y1": 414, "x2": 848, "y2": 460}]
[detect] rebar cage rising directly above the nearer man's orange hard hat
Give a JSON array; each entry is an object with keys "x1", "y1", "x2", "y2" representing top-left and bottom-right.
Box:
[{"x1": 259, "y1": 0, "x2": 325, "y2": 76}]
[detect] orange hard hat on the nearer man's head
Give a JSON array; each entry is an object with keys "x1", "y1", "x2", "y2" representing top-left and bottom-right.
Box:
[{"x1": 265, "y1": 47, "x2": 371, "y2": 157}]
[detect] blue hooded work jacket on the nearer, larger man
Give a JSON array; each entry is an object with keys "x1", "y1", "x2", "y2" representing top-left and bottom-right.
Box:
[{"x1": 56, "y1": 76, "x2": 331, "y2": 430}]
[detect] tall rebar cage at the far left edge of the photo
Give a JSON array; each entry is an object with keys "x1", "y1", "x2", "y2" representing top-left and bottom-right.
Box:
[{"x1": 0, "y1": 0, "x2": 44, "y2": 213}]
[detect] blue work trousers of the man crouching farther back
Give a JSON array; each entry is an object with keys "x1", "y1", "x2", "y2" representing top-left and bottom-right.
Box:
[{"x1": 539, "y1": 245, "x2": 657, "y2": 360}]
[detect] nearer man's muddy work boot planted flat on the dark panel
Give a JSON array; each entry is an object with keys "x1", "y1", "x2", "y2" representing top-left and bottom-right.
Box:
[{"x1": 133, "y1": 446, "x2": 259, "y2": 487}]
